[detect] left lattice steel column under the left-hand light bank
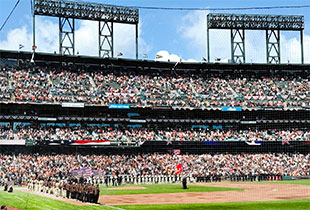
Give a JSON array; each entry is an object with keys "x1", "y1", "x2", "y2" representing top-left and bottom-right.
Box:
[{"x1": 59, "y1": 17, "x2": 75, "y2": 55}]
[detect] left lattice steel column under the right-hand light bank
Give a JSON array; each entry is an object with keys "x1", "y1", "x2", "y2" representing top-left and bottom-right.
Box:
[{"x1": 230, "y1": 29, "x2": 245, "y2": 63}]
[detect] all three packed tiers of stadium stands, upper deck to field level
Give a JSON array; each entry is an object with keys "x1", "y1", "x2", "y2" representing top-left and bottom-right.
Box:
[{"x1": 0, "y1": 52, "x2": 310, "y2": 187}]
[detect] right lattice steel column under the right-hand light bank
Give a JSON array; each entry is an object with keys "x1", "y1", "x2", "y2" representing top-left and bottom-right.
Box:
[{"x1": 266, "y1": 30, "x2": 281, "y2": 64}]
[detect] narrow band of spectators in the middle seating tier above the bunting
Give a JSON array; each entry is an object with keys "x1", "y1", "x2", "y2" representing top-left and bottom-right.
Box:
[{"x1": 0, "y1": 125, "x2": 310, "y2": 143}]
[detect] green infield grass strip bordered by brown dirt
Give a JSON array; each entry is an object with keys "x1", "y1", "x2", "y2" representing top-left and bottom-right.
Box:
[{"x1": 100, "y1": 184, "x2": 243, "y2": 195}]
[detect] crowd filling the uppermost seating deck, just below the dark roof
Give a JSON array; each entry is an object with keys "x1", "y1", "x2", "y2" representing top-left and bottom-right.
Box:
[{"x1": 0, "y1": 68, "x2": 310, "y2": 108}]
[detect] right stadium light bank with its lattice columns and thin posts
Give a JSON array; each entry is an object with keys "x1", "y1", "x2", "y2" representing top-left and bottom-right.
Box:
[{"x1": 207, "y1": 13, "x2": 304, "y2": 64}]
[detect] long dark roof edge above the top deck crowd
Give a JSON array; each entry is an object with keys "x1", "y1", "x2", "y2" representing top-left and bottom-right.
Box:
[{"x1": 0, "y1": 50, "x2": 310, "y2": 73}]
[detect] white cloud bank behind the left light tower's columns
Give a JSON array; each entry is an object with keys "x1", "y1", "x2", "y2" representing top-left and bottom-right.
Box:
[{"x1": 0, "y1": 18, "x2": 150, "y2": 58}]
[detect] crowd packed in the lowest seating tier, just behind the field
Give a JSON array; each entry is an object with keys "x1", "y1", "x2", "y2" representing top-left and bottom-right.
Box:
[{"x1": 0, "y1": 153, "x2": 310, "y2": 182}]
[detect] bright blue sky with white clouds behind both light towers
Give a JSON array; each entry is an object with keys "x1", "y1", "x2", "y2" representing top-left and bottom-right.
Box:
[{"x1": 0, "y1": 0, "x2": 310, "y2": 63}]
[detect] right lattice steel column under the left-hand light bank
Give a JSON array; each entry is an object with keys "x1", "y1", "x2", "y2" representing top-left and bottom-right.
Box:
[{"x1": 99, "y1": 21, "x2": 114, "y2": 58}]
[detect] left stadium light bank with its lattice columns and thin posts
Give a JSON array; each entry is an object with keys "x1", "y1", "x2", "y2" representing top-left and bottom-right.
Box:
[{"x1": 32, "y1": 0, "x2": 139, "y2": 59}]
